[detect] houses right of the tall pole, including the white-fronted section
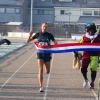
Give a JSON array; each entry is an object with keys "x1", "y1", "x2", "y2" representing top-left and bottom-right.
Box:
[{"x1": 33, "y1": 0, "x2": 100, "y2": 25}]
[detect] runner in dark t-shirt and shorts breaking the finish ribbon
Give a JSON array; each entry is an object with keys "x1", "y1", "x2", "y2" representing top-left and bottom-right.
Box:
[{"x1": 27, "y1": 23, "x2": 57, "y2": 92}]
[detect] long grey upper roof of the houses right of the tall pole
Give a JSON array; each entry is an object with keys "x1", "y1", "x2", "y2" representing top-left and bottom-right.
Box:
[{"x1": 33, "y1": 0, "x2": 100, "y2": 8}]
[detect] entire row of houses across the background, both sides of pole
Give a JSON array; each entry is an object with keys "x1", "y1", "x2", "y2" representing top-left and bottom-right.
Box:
[{"x1": 0, "y1": 0, "x2": 100, "y2": 35}]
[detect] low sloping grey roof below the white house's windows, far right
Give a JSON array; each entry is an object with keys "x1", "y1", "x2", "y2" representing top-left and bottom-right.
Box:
[{"x1": 78, "y1": 16, "x2": 100, "y2": 25}]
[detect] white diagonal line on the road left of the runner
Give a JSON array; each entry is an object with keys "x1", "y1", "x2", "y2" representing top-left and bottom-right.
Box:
[{"x1": 0, "y1": 52, "x2": 36, "y2": 90}]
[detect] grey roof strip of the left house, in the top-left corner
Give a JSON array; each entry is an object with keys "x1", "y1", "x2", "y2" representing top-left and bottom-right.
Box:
[{"x1": 0, "y1": 0, "x2": 24, "y2": 6}]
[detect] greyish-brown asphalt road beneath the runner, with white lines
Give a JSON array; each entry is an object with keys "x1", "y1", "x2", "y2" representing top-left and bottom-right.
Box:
[{"x1": 0, "y1": 41, "x2": 100, "y2": 100}]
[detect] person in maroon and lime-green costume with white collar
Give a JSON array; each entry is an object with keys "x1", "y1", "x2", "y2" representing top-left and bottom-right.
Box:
[{"x1": 74, "y1": 23, "x2": 100, "y2": 89}]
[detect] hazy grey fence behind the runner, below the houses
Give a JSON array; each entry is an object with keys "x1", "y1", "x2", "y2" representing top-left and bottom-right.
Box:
[{"x1": 0, "y1": 25, "x2": 83, "y2": 38}]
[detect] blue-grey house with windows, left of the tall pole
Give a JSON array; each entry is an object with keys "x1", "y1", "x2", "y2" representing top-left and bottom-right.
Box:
[{"x1": 0, "y1": 0, "x2": 28, "y2": 25}]
